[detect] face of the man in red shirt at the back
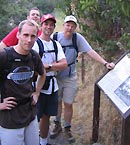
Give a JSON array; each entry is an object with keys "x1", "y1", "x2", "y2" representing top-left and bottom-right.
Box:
[{"x1": 27, "y1": 10, "x2": 40, "y2": 24}]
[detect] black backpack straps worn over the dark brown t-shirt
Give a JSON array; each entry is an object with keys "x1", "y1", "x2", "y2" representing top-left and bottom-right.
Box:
[{"x1": 0, "y1": 47, "x2": 36, "y2": 96}]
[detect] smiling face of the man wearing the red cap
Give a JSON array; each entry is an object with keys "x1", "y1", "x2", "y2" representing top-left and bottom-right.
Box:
[{"x1": 41, "y1": 19, "x2": 55, "y2": 36}]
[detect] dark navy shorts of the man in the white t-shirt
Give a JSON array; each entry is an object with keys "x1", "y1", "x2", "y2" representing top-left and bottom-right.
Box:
[{"x1": 37, "y1": 91, "x2": 58, "y2": 120}]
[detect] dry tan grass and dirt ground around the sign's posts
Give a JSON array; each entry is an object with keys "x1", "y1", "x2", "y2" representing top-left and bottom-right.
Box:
[{"x1": 49, "y1": 57, "x2": 122, "y2": 145}]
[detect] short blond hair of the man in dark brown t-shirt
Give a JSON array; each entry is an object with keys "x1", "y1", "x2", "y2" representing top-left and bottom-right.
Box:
[{"x1": 18, "y1": 20, "x2": 39, "y2": 33}]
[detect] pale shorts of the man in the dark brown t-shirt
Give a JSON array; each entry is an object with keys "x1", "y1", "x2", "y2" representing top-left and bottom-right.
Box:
[{"x1": 0, "y1": 117, "x2": 39, "y2": 145}]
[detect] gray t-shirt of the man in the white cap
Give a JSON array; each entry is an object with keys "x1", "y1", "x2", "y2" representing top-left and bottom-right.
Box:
[{"x1": 52, "y1": 32, "x2": 92, "y2": 79}]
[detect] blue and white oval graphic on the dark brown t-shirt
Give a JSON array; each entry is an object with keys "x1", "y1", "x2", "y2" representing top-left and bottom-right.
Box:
[{"x1": 7, "y1": 66, "x2": 34, "y2": 84}]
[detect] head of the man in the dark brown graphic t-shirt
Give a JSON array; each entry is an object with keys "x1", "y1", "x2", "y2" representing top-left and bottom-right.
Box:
[{"x1": 17, "y1": 24, "x2": 37, "y2": 51}]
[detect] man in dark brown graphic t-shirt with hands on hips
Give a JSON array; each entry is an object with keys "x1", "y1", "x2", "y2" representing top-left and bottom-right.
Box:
[{"x1": 0, "y1": 20, "x2": 46, "y2": 145}]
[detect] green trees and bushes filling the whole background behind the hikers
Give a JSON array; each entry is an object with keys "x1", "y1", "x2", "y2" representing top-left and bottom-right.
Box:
[{"x1": 0, "y1": 0, "x2": 130, "y2": 53}]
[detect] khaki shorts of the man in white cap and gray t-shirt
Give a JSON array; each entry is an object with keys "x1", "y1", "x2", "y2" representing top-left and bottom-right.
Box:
[{"x1": 57, "y1": 77, "x2": 78, "y2": 104}]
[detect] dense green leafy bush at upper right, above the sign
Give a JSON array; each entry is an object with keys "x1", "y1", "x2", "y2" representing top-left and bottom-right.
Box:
[{"x1": 56, "y1": 0, "x2": 130, "y2": 59}]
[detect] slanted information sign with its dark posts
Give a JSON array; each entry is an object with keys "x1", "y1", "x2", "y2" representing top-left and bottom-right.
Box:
[{"x1": 92, "y1": 51, "x2": 130, "y2": 145}]
